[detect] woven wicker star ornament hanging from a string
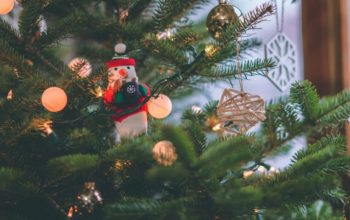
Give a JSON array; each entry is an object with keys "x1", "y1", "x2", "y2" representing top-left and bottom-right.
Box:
[{"x1": 217, "y1": 89, "x2": 265, "y2": 135}]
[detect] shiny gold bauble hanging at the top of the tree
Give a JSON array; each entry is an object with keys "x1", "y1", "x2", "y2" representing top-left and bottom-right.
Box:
[{"x1": 207, "y1": 0, "x2": 239, "y2": 39}]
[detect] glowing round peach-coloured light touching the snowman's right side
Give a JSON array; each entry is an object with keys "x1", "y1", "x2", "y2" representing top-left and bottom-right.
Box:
[{"x1": 148, "y1": 94, "x2": 173, "y2": 119}]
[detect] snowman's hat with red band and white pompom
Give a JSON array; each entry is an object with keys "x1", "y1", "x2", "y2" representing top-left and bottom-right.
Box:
[{"x1": 106, "y1": 43, "x2": 136, "y2": 69}]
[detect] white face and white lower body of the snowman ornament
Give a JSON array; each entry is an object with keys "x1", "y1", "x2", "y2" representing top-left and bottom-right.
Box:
[{"x1": 108, "y1": 62, "x2": 148, "y2": 142}]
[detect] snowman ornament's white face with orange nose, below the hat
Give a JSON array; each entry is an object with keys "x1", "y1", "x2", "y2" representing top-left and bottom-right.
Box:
[{"x1": 108, "y1": 66, "x2": 137, "y2": 83}]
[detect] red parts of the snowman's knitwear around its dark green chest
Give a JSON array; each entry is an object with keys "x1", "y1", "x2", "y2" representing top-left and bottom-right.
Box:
[{"x1": 103, "y1": 84, "x2": 151, "y2": 122}]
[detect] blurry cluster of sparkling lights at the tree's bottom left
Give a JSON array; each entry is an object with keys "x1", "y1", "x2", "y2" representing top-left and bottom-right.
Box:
[{"x1": 67, "y1": 182, "x2": 103, "y2": 218}]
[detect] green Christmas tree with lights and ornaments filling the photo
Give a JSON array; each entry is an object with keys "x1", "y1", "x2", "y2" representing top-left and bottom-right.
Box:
[{"x1": 0, "y1": 0, "x2": 350, "y2": 220}]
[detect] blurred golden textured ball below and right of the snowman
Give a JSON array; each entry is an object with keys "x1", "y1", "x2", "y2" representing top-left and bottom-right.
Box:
[{"x1": 152, "y1": 141, "x2": 177, "y2": 166}]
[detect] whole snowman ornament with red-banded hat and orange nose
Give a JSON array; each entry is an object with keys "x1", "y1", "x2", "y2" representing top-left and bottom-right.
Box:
[{"x1": 103, "y1": 44, "x2": 150, "y2": 142}]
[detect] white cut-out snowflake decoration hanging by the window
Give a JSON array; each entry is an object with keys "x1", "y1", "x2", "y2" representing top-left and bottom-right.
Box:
[{"x1": 265, "y1": 33, "x2": 296, "y2": 91}]
